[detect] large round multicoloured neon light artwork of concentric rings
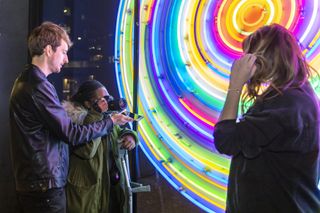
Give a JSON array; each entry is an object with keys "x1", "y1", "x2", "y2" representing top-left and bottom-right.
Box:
[{"x1": 115, "y1": 0, "x2": 320, "y2": 212}]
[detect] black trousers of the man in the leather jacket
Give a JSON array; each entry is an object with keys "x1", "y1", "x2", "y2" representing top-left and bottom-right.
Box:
[{"x1": 17, "y1": 188, "x2": 66, "y2": 213}]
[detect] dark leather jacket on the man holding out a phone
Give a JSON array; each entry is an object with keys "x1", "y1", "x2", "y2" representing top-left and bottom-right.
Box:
[{"x1": 10, "y1": 65, "x2": 113, "y2": 191}]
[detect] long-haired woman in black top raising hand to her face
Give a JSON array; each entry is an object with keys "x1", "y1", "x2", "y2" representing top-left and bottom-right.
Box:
[{"x1": 214, "y1": 24, "x2": 320, "y2": 213}]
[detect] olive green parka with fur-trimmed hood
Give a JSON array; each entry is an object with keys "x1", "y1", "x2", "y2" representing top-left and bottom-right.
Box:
[{"x1": 63, "y1": 102, "x2": 138, "y2": 213}]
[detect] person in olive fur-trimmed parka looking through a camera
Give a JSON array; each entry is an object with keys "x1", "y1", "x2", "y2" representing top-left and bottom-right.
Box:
[{"x1": 63, "y1": 80, "x2": 138, "y2": 213}]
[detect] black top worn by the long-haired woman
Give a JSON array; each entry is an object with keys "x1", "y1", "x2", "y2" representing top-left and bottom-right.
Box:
[{"x1": 214, "y1": 83, "x2": 320, "y2": 213}]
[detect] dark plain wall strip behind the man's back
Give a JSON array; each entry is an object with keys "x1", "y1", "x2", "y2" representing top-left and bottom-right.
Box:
[{"x1": 0, "y1": 0, "x2": 29, "y2": 213}]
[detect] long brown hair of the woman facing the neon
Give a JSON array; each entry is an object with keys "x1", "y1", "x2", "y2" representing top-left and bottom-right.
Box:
[{"x1": 242, "y1": 24, "x2": 311, "y2": 110}]
